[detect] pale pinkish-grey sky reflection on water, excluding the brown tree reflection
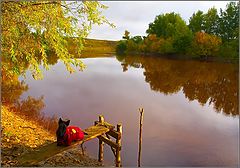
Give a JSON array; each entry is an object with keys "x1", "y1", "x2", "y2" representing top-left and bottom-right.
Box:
[{"x1": 22, "y1": 58, "x2": 239, "y2": 166}]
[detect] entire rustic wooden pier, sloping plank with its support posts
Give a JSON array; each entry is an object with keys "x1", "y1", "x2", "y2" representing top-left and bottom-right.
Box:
[{"x1": 18, "y1": 115, "x2": 122, "y2": 167}]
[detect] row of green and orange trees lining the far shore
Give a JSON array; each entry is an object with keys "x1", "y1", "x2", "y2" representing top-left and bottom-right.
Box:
[{"x1": 116, "y1": 2, "x2": 239, "y2": 59}]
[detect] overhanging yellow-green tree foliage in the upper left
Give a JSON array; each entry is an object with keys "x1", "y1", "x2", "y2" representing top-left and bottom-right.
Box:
[{"x1": 1, "y1": 0, "x2": 113, "y2": 78}]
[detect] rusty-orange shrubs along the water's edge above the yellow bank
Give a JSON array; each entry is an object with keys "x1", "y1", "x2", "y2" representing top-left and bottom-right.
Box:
[{"x1": 1, "y1": 77, "x2": 58, "y2": 134}]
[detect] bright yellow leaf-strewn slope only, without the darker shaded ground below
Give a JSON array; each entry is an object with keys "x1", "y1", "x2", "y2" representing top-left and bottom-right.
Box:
[{"x1": 1, "y1": 105, "x2": 55, "y2": 148}]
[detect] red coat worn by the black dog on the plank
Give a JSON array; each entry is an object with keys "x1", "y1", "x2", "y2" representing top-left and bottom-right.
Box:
[{"x1": 64, "y1": 126, "x2": 84, "y2": 145}]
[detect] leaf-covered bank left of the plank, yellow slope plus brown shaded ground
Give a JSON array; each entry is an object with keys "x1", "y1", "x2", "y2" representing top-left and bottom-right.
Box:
[{"x1": 1, "y1": 105, "x2": 55, "y2": 166}]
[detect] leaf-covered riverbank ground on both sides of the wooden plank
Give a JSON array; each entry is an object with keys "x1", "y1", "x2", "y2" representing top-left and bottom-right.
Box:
[{"x1": 1, "y1": 105, "x2": 102, "y2": 167}]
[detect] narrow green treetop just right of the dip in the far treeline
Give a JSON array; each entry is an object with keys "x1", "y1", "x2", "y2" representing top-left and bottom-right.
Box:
[{"x1": 188, "y1": 10, "x2": 204, "y2": 33}]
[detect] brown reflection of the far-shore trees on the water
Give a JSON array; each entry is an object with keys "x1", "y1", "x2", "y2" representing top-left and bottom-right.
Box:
[{"x1": 118, "y1": 56, "x2": 239, "y2": 116}]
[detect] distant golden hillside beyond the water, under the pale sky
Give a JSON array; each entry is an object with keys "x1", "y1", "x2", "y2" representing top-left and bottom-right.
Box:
[{"x1": 69, "y1": 39, "x2": 117, "y2": 58}]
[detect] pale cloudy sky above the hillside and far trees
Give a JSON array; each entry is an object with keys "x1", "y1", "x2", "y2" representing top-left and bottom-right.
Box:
[{"x1": 88, "y1": 1, "x2": 229, "y2": 40}]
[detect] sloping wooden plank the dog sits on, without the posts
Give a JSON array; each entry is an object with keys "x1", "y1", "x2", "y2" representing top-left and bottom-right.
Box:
[{"x1": 18, "y1": 123, "x2": 114, "y2": 166}]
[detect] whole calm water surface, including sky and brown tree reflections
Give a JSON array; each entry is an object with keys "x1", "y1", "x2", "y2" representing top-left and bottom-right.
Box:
[{"x1": 22, "y1": 56, "x2": 239, "y2": 166}]
